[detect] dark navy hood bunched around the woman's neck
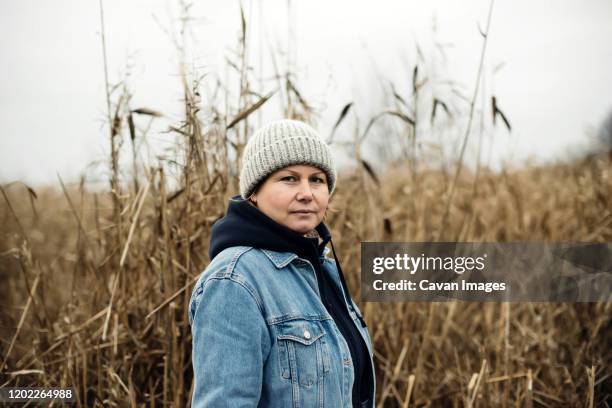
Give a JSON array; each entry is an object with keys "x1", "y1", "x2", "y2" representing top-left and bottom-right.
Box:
[{"x1": 208, "y1": 196, "x2": 331, "y2": 260}]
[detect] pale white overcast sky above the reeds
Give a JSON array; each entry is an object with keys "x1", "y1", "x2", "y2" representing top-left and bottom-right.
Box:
[{"x1": 0, "y1": 0, "x2": 612, "y2": 184}]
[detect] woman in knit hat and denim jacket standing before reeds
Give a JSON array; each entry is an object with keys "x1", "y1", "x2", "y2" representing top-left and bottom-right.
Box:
[{"x1": 189, "y1": 120, "x2": 375, "y2": 408}]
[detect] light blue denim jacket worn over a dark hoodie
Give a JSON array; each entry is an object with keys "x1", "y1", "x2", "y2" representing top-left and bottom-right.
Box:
[{"x1": 189, "y1": 246, "x2": 376, "y2": 408}]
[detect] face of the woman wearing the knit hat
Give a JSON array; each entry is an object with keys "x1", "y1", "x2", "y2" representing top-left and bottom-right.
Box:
[{"x1": 251, "y1": 164, "x2": 329, "y2": 234}]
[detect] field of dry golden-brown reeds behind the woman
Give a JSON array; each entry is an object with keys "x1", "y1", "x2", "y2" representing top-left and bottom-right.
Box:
[{"x1": 0, "y1": 2, "x2": 612, "y2": 407}]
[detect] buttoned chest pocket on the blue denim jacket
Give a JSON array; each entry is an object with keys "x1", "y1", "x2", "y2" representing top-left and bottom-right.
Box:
[{"x1": 277, "y1": 319, "x2": 330, "y2": 390}]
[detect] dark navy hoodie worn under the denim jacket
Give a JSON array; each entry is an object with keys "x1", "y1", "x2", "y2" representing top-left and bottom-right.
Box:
[{"x1": 209, "y1": 196, "x2": 374, "y2": 407}]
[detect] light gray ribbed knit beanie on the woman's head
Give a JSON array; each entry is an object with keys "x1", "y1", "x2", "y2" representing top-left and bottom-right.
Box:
[{"x1": 240, "y1": 119, "x2": 336, "y2": 199}]
